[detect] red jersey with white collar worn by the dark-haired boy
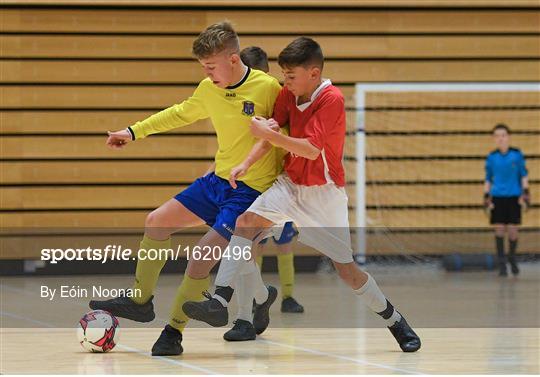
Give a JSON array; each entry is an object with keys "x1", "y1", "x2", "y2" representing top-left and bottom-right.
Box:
[{"x1": 273, "y1": 80, "x2": 345, "y2": 187}]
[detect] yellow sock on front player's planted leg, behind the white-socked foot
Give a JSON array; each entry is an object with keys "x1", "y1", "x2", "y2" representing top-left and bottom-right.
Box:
[{"x1": 169, "y1": 275, "x2": 210, "y2": 332}]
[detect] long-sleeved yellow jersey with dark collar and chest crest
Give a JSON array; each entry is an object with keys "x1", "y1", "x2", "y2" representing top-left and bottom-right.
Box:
[{"x1": 130, "y1": 68, "x2": 283, "y2": 192}]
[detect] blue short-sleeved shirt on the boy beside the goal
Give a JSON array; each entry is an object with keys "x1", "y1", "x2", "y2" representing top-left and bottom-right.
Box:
[{"x1": 486, "y1": 148, "x2": 527, "y2": 197}]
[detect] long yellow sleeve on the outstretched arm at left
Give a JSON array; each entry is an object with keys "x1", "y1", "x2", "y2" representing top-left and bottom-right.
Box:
[{"x1": 130, "y1": 83, "x2": 208, "y2": 140}]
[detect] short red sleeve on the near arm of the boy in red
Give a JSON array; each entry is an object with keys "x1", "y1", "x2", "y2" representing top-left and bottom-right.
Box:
[{"x1": 304, "y1": 92, "x2": 345, "y2": 150}]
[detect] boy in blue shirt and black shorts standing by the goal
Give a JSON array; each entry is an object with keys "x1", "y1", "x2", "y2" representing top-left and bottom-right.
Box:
[{"x1": 484, "y1": 124, "x2": 530, "y2": 276}]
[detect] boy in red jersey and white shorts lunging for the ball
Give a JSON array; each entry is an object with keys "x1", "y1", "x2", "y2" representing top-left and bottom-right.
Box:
[{"x1": 183, "y1": 37, "x2": 420, "y2": 352}]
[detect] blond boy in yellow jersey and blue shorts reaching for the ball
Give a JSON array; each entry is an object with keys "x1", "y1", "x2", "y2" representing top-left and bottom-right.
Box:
[{"x1": 90, "y1": 22, "x2": 281, "y2": 356}]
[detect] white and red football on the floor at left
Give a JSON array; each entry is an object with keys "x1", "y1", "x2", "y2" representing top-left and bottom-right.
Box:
[{"x1": 77, "y1": 310, "x2": 119, "y2": 352}]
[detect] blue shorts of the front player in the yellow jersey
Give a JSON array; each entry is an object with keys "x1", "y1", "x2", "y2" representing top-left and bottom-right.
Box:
[{"x1": 174, "y1": 173, "x2": 261, "y2": 241}]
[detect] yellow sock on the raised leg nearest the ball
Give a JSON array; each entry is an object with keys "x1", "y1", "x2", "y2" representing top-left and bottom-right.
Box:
[{"x1": 132, "y1": 235, "x2": 171, "y2": 304}]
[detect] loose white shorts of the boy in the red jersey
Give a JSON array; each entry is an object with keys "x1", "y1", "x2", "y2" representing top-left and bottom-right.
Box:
[{"x1": 246, "y1": 174, "x2": 353, "y2": 263}]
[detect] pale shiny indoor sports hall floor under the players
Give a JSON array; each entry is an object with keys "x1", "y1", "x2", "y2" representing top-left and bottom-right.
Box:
[{"x1": 0, "y1": 262, "x2": 540, "y2": 374}]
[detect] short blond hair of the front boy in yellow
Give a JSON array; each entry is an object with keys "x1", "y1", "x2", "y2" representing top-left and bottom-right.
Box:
[{"x1": 192, "y1": 21, "x2": 240, "y2": 59}]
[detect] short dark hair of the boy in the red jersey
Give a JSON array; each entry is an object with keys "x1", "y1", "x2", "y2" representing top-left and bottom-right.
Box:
[{"x1": 278, "y1": 37, "x2": 324, "y2": 70}]
